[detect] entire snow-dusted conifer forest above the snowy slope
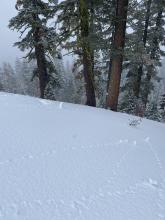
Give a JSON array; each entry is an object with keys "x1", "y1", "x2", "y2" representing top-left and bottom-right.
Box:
[{"x1": 0, "y1": 0, "x2": 165, "y2": 121}]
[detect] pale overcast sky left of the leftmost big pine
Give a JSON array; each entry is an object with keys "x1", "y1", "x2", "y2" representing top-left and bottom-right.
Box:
[{"x1": 0, "y1": 0, "x2": 22, "y2": 63}]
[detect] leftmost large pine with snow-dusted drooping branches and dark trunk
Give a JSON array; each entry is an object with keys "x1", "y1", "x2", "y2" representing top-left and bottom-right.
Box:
[{"x1": 9, "y1": 0, "x2": 56, "y2": 98}]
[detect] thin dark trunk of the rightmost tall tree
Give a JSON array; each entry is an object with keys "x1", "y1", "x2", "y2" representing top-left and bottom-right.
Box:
[{"x1": 143, "y1": 4, "x2": 163, "y2": 108}]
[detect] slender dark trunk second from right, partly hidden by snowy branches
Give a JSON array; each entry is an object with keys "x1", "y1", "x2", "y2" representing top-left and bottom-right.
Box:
[{"x1": 134, "y1": 0, "x2": 152, "y2": 99}]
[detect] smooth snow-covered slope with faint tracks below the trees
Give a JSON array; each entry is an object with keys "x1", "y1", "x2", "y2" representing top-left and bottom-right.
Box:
[{"x1": 0, "y1": 93, "x2": 165, "y2": 220}]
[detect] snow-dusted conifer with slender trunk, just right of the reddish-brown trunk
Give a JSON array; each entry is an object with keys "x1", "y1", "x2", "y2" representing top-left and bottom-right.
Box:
[{"x1": 122, "y1": 0, "x2": 152, "y2": 115}]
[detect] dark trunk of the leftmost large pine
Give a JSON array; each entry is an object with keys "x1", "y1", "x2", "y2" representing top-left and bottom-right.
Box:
[{"x1": 33, "y1": 0, "x2": 48, "y2": 98}]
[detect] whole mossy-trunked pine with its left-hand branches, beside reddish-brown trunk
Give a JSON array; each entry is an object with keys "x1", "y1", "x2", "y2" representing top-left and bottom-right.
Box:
[{"x1": 54, "y1": 0, "x2": 100, "y2": 106}]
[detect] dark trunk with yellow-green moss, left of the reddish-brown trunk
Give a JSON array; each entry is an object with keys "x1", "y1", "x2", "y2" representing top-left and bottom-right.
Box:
[{"x1": 80, "y1": 0, "x2": 96, "y2": 106}]
